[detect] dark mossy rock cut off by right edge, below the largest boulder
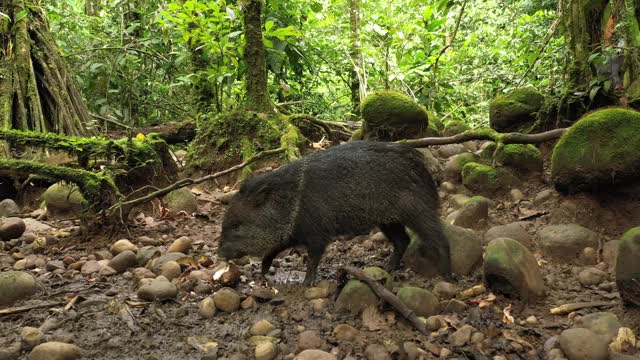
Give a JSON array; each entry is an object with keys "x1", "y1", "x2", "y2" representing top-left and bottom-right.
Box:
[{"x1": 616, "y1": 232, "x2": 640, "y2": 306}]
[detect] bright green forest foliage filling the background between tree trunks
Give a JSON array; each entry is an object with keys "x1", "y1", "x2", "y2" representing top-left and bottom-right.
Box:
[{"x1": 46, "y1": 0, "x2": 565, "y2": 130}]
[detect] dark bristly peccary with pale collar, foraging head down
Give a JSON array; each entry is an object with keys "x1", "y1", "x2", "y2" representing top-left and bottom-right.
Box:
[{"x1": 218, "y1": 141, "x2": 451, "y2": 286}]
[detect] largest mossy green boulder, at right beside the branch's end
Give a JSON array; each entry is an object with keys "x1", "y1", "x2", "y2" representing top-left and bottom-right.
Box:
[{"x1": 551, "y1": 108, "x2": 640, "y2": 192}]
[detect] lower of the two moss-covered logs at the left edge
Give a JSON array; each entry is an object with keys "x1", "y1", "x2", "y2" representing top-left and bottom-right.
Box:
[{"x1": 0, "y1": 159, "x2": 121, "y2": 212}]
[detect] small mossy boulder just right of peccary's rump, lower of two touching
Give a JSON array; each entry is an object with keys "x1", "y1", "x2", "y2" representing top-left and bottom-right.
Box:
[{"x1": 462, "y1": 162, "x2": 516, "y2": 194}]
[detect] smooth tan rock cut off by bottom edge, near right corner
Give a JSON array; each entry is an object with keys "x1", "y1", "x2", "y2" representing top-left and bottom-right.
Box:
[{"x1": 559, "y1": 328, "x2": 609, "y2": 360}]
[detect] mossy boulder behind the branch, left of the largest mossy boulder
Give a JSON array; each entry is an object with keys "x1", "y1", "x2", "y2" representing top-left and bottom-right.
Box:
[{"x1": 489, "y1": 87, "x2": 544, "y2": 132}]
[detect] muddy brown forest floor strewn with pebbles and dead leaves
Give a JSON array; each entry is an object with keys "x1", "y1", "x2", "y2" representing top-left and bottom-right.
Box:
[{"x1": 0, "y1": 142, "x2": 640, "y2": 359}]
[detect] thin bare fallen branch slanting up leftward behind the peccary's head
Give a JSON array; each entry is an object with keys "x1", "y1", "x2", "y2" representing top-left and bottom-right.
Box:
[{"x1": 107, "y1": 148, "x2": 286, "y2": 215}]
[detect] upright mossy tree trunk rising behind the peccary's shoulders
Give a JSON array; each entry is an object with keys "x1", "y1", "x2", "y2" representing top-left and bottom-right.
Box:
[{"x1": 242, "y1": 0, "x2": 275, "y2": 113}]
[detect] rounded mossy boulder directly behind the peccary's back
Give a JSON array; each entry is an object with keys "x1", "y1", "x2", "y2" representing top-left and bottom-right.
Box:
[{"x1": 360, "y1": 90, "x2": 429, "y2": 140}]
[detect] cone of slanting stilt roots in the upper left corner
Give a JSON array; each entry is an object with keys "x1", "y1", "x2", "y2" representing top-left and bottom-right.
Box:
[{"x1": 0, "y1": 0, "x2": 91, "y2": 135}]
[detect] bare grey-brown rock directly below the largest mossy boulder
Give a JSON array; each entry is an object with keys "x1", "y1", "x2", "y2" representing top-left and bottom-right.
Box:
[{"x1": 539, "y1": 224, "x2": 598, "y2": 262}]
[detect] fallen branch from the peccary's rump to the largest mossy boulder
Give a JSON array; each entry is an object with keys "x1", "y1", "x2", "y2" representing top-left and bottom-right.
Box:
[{"x1": 397, "y1": 128, "x2": 567, "y2": 148}]
